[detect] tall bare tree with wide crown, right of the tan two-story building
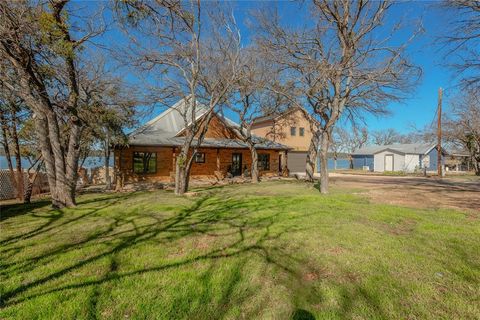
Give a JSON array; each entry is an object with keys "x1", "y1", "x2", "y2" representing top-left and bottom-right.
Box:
[{"x1": 260, "y1": 0, "x2": 419, "y2": 193}]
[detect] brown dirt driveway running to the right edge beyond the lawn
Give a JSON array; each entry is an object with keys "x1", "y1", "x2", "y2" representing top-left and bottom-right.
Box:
[{"x1": 330, "y1": 174, "x2": 480, "y2": 215}]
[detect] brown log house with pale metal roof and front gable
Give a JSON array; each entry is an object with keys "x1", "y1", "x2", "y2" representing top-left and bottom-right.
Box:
[{"x1": 114, "y1": 100, "x2": 288, "y2": 183}]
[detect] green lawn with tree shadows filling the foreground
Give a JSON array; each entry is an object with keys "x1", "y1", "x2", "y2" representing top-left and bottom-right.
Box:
[{"x1": 0, "y1": 181, "x2": 480, "y2": 319}]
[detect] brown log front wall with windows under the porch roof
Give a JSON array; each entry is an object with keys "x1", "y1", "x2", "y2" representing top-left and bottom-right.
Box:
[{"x1": 114, "y1": 146, "x2": 288, "y2": 185}]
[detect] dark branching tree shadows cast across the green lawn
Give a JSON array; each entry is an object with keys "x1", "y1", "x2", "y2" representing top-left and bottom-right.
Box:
[{"x1": 1, "y1": 188, "x2": 420, "y2": 319}]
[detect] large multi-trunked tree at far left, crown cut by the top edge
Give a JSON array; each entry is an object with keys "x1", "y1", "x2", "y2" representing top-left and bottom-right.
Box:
[{"x1": 0, "y1": 0, "x2": 117, "y2": 207}]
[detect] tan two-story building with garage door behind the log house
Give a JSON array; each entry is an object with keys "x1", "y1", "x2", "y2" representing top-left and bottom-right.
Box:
[{"x1": 252, "y1": 107, "x2": 316, "y2": 173}]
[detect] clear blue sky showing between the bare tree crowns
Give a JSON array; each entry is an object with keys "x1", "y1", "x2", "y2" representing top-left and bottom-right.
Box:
[{"x1": 79, "y1": 1, "x2": 464, "y2": 132}]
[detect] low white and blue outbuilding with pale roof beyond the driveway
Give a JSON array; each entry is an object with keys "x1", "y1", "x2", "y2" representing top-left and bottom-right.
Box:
[{"x1": 352, "y1": 143, "x2": 445, "y2": 172}]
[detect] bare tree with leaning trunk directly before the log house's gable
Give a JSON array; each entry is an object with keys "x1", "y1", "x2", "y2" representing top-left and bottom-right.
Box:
[{"x1": 118, "y1": 0, "x2": 241, "y2": 195}]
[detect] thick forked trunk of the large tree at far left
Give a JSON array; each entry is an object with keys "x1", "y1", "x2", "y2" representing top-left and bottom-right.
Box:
[{"x1": 4, "y1": 30, "x2": 82, "y2": 208}]
